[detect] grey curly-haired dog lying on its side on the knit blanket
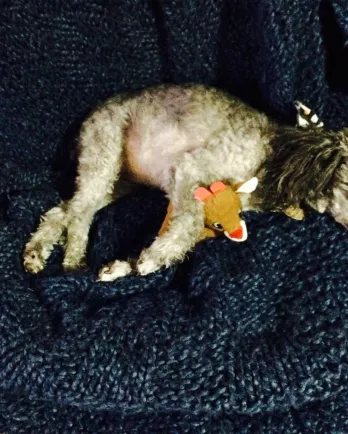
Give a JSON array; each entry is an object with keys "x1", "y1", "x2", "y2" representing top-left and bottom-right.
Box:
[{"x1": 24, "y1": 85, "x2": 348, "y2": 280}]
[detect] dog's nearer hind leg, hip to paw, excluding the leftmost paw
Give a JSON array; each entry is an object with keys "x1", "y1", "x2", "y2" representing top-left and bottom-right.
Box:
[{"x1": 63, "y1": 100, "x2": 128, "y2": 270}]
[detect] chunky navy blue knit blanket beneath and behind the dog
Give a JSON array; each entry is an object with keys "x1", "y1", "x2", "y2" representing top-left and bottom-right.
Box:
[{"x1": 0, "y1": 0, "x2": 348, "y2": 434}]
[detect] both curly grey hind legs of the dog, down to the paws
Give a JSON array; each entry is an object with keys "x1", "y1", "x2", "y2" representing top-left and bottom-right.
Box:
[{"x1": 24, "y1": 98, "x2": 128, "y2": 273}]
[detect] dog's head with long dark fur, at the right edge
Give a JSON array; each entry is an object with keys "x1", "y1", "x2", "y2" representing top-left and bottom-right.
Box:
[{"x1": 259, "y1": 128, "x2": 348, "y2": 228}]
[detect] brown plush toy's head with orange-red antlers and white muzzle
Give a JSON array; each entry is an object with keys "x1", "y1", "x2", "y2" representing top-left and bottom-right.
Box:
[{"x1": 195, "y1": 178, "x2": 257, "y2": 242}]
